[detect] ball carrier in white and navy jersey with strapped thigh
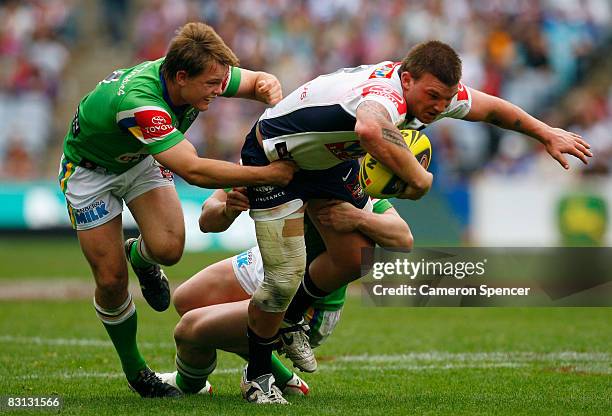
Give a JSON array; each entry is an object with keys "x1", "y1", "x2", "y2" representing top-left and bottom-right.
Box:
[{"x1": 237, "y1": 41, "x2": 591, "y2": 401}]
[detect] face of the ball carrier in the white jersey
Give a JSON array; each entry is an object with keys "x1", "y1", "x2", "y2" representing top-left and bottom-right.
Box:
[{"x1": 402, "y1": 72, "x2": 458, "y2": 124}]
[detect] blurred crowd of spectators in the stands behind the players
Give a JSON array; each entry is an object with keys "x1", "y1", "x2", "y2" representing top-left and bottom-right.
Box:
[{"x1": 0, "y1": 0, "x2": 612, "y2": 184}]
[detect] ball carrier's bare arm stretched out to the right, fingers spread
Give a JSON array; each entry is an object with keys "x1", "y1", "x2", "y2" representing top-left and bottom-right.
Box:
[{"x1": 464, "y1": 89, "x2": 593, "y2": 169}]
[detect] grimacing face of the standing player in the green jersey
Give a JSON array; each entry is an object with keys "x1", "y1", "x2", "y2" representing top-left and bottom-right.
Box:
[{"x1": 181, "y1": 63, "x2": 229, "y2": 111}]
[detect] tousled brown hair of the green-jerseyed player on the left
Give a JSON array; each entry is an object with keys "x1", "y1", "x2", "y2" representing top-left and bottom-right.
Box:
[{"x1": 161, "y1": 22, "x2": 240, "y2": 80}]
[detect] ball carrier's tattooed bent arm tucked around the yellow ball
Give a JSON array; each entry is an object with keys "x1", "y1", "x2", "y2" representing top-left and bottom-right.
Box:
[{"x1": 355, "y1": 101, "x2": 433, "y2": 199}]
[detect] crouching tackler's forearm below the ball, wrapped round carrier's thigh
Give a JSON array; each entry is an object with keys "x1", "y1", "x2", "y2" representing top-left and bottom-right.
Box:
[{"x1": 317, "y1": 200, "x2": 414, "y2": 248}]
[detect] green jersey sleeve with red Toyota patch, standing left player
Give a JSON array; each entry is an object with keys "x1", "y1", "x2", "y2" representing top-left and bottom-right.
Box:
[{"x1": 116, "y1": 95, "x2": 185, "y2": 155}]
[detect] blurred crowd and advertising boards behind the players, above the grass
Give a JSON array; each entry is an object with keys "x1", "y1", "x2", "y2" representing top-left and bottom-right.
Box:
[{"x1": 0, "y1": 0, "x2": 612, "y2": 251}]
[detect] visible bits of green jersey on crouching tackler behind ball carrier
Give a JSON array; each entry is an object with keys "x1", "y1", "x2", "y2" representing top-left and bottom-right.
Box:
[{"x1": 304, "y1": 199, "x2": 393, "y2": 311}]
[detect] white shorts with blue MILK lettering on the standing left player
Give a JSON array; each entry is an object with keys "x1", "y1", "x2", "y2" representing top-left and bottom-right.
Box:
[{"x1": 59, "y1": 155, "x2": 174, "y2": 230}]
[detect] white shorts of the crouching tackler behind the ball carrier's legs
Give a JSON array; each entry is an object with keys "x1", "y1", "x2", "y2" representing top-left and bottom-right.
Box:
[{"x1": 232, "y1": 246, "x2": 342, "y2": 348}]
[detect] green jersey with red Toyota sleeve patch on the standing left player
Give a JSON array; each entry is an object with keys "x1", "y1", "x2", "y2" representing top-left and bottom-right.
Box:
[{"x1": 64, "y1": 58, "x2": 240, "y2": 174}]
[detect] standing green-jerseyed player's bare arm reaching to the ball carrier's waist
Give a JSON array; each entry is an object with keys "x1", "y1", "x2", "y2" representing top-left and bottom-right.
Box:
[{"x1": 153, "y1": 140, "x2": 297, "y2": 188}]
